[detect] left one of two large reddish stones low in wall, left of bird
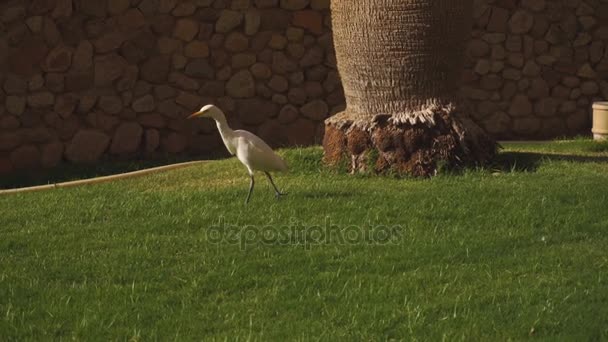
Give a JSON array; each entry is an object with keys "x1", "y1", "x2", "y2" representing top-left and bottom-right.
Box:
[{"x1": 65, "y1": 129, "x2": 110, "y2": 163}]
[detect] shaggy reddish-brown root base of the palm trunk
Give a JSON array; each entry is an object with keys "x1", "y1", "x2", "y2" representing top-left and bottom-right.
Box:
[{"x1": 323, "y1": 106, "x2": 497, "y2": 177}]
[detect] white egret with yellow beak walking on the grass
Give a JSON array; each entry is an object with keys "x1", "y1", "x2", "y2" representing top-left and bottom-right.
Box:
[{"x1": 188, "y1": 105, "x2": 287, "y2": 204}]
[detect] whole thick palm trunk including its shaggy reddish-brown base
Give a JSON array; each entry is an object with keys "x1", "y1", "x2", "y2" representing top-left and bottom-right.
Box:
[{"x1": 324, "y1": 0, "x2": 496, "y2": 175}]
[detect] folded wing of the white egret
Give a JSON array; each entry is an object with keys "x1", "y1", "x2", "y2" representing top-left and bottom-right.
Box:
[{"x1": 235, "y1": 130, "x2": 287, "y2": 171}]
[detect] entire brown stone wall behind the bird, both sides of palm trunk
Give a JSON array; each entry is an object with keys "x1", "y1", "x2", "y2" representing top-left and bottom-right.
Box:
[{"x1": 0, "y1": 0, "x2": 608, "y2": 174}]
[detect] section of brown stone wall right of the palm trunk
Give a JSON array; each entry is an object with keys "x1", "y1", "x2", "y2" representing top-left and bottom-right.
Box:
[{"x1": 463, "y1": 0, "x2": 608, "y2": 139}]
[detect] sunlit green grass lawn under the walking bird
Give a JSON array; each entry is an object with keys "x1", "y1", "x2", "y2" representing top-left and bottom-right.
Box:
[{"x1": 0, "y1": 140, "x2": 608, "y2": 341}]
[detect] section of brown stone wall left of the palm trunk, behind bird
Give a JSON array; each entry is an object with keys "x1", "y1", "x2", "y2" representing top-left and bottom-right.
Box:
[{"x1": 0, "y1": 0, "x2": 344, "y2": 173}]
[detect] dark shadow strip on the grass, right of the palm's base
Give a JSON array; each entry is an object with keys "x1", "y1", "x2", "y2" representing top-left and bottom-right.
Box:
[{"x1": 492, "y1": 152, "x2": 608, "y2": 172}]
